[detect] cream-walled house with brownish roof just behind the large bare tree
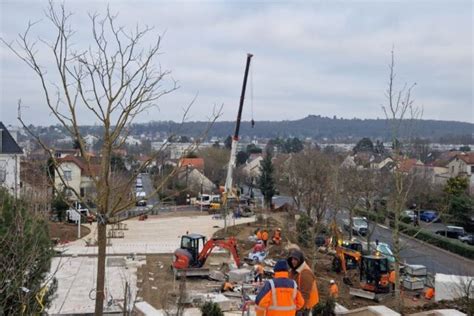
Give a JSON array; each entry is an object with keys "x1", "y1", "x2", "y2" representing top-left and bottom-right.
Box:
[{"x1": 54, "y1": 156, "x2": 100, "y2": 201}]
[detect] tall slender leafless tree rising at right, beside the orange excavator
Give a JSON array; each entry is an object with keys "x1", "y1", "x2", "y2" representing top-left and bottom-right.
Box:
[{"x1": 382, "y1": 50, "x2": 422, "y2": 311}]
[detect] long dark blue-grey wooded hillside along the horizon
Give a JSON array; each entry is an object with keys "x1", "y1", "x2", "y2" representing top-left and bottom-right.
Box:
[{"x1": 132, "y1": 115, "x2": 474, "y2": 141}]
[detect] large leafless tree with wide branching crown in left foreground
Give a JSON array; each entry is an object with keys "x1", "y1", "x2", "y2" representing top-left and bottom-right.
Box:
[{"x1": 1, "y1": 2, "x2": 219, "y2": 315}]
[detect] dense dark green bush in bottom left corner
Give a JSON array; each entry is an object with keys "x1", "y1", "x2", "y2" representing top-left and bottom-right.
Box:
[{"x1": 0, "y1": 190, "x2": 57, "y2": 315}]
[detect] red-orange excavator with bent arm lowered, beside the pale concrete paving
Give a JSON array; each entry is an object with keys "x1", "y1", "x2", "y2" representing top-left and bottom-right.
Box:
[{"x1": 173, "y1": 234, "x2": 241, "y2": 276}]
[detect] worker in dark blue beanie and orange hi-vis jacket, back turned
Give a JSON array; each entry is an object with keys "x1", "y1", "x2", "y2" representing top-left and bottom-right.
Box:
[{"x1": 255, "y1": 260, "x2": 304, "y2": 316}]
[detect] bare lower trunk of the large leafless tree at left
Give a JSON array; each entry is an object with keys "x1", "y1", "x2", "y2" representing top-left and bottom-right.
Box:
[{"x1": 94, "y1": 219, "x2": 107, "y2": 316}]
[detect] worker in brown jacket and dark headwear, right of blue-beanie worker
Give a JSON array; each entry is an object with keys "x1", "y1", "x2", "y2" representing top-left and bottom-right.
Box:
[{"x1": 287, "y1": 249, "x2": 319, "y2": 316}]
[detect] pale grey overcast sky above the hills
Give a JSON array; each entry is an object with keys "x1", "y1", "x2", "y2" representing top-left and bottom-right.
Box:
[{"x1": 0, "y1": 0, "x2": 474, "y2": 125}]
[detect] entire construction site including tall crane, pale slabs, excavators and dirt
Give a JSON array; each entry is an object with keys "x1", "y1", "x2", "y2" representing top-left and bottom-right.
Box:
[{"x1": 43, "y1": 54, "x2": 474, "y2": 315}]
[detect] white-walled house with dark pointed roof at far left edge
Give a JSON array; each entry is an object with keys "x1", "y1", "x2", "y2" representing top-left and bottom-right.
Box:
[{"x1": 0, "y1": 122, "x2": 23, "y2": 197}]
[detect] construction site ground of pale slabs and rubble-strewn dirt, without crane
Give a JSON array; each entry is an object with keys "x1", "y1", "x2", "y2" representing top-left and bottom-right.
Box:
[{"x1": 49, "y1": 206, "x2": 472, "y2": 315}]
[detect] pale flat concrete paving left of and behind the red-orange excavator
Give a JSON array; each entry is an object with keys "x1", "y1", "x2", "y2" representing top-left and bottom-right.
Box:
[{"x1": 48, "y1": 215, "x2": 254, "y2": 314}]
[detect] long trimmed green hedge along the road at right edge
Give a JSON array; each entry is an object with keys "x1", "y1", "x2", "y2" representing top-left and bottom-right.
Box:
[{"x1": 400, "y1": 222, "x2": 474, "y2": 259}]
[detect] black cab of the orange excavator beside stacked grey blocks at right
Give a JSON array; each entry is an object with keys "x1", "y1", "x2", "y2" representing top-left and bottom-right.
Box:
[{"x1": 360, "y1": 255, "x2": 390, "y2": 293}]
